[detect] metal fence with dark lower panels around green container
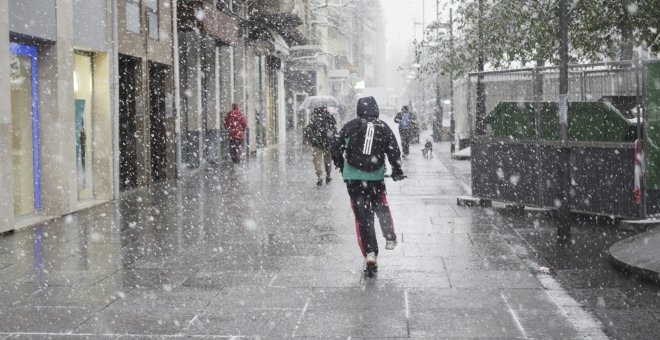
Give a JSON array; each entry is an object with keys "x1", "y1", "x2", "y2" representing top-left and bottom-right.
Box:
[{"x1": 462, "y1": 63, "x2": 648, "y2": 217}]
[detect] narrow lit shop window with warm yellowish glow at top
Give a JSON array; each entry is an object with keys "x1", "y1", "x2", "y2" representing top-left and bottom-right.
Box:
[{"x1": 73, "y1": 53, "x2": 94, "y2": 200}]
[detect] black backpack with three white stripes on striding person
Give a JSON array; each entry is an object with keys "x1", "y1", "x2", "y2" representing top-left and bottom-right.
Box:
[{"x1": 346, "y1": 119, "x2": 387, "y2": 171}]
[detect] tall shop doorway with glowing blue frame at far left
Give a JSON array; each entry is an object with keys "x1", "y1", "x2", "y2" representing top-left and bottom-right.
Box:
[{"x1": 9, "y1": 43, "x2": 41, "y2": 216}]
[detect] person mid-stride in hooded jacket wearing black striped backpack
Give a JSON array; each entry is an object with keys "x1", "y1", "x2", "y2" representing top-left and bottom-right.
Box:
[{"x1": 332, "y1": 97, "x2": 404, "y2": 274}]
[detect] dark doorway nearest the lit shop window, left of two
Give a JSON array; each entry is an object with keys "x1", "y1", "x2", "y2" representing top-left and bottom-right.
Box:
[{"x1": 119, "y1": 56, "x2": 139, "y2": 190}]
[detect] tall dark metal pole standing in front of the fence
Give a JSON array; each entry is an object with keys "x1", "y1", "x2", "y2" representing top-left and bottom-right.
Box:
[{"x1": 557, "y1": 0, "x2": 571, "y2": 242}]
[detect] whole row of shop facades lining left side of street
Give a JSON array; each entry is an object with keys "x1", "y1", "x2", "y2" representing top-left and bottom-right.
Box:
[{"x1": 0, "y1": 0, "x2": 308, "y2": 232}]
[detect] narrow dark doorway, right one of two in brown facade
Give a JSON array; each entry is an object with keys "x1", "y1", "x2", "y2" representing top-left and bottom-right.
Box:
[{"x1": 149, "y1": 64, "x2": 168, "y2": 182}]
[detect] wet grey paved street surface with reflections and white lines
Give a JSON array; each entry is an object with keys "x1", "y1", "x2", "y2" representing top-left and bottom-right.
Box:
[{"x1": 0, "y1": 126, "x2": 660, "y2": 339}]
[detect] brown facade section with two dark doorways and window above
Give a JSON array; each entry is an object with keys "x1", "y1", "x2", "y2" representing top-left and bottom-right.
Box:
[{"x1": 114, "y1": 0, "x2": 176, "y2": 191}]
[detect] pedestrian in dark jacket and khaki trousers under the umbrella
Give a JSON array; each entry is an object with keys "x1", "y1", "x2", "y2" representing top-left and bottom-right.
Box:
[{"x1": 304, "y1": 107, "x2": 337, "y2": 186}]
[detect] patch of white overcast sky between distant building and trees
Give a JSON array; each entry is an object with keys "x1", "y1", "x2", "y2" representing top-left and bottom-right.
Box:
[{"x1": 380, "y1": 0, "x2": 449, "y2": 89}]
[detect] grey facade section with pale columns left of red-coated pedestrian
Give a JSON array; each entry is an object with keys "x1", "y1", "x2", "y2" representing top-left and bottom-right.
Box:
[{"x1": 177, "y1": 0, "x2": 245, "y2": 172}]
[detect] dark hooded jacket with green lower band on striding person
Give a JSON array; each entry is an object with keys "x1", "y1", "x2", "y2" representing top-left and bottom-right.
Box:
[{"x1": 332, "y1": 97, "x2": 403, "y2": 181}]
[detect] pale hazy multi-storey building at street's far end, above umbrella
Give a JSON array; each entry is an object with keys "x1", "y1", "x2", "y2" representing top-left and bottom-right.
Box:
[{"x1": 287, "y1": 0, "x2": 385, "y2": 128}]
